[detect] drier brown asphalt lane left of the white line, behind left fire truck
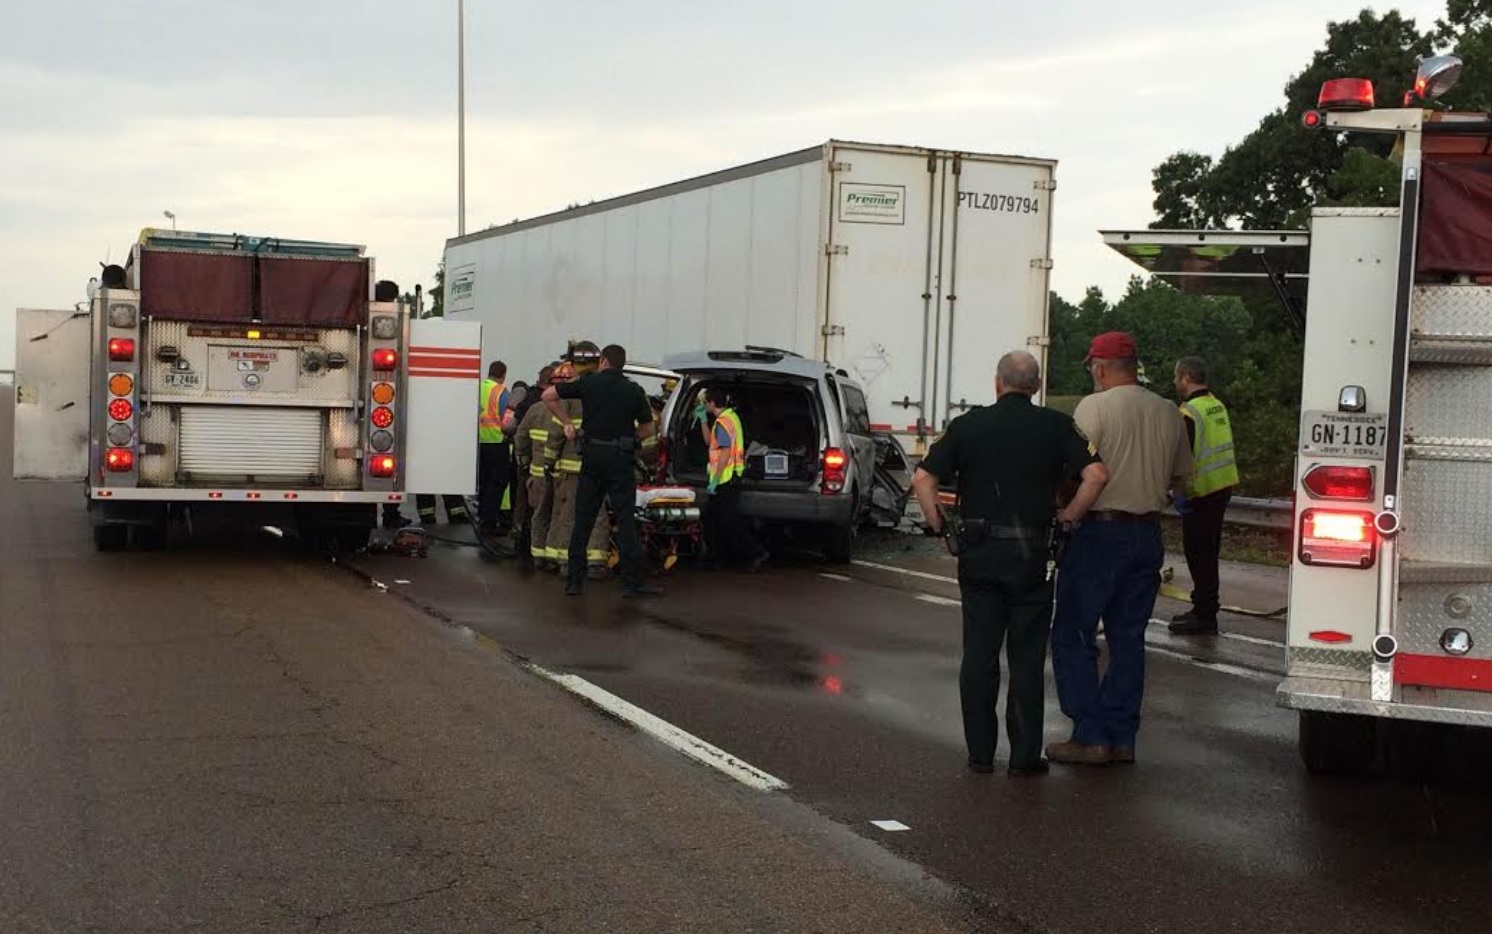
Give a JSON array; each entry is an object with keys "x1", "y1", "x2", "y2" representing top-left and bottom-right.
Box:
[{"x1": 0, "y1": 387, "x2": 1001, "y2": 934}]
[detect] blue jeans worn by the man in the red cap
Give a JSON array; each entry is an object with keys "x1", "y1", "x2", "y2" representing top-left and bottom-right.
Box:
[{"x1": 1052, "y1": 521, "x2": 1165, "y2": 746}]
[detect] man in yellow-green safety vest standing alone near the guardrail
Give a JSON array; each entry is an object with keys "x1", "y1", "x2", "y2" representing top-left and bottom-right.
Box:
[{"x1": 1170, "y1": 357, "x2": 1238, "y2": 636}]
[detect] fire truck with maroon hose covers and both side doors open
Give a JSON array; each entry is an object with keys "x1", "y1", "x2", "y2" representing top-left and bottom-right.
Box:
[{"x1": 15, "y1": 228, "x2": 482, "y2": 551}]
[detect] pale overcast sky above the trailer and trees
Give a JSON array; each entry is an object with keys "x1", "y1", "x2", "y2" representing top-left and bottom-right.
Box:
[{"x1": 0, "y1": 0, "x2": 1444, "y2": 369}]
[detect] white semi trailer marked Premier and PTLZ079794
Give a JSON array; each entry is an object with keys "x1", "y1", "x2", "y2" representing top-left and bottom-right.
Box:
[{"x1": 445, "y1": 142, "x2": 1056, "y2": 449}]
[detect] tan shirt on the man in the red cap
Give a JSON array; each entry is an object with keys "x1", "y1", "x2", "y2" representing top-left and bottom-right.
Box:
[{"x1": 1073, "y1": 385, "x2": 1192, "y2": 513}]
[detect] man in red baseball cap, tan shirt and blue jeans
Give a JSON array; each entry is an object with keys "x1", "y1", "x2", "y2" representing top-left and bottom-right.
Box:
[{"x1": 1046, "y1": 331, "x2": 1192, "y2": 765}]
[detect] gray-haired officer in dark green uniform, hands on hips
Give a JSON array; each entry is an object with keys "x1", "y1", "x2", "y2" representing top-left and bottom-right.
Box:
[{"x1": 912, "y1": 351, "x2": 1109, "y2": 777}]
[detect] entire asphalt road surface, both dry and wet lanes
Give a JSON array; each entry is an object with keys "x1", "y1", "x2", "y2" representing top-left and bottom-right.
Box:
[{"x1": 11, "y1": 378, "x2": 1492, "y2": 934}]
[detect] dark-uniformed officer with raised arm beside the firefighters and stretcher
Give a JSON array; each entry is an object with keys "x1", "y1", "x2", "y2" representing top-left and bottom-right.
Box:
[{"x1": 545, "y1": 340, "x2": 661, "y2": 597}]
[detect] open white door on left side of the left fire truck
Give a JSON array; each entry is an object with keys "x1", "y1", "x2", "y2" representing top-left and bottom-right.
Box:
[{"x1": 12, "y1": 309, "x2": 93, "y2": 480}]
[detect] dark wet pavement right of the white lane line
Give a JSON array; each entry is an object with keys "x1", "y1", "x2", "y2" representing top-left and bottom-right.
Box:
[{"x1": 355, "y1": 525, "x2": 1492, "y2": 934}]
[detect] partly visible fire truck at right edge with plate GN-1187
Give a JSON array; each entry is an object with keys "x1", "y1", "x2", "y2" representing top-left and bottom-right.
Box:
[{"x1": 1103, "y1": 55, "x2": 1492, "y2": 773}]
